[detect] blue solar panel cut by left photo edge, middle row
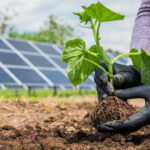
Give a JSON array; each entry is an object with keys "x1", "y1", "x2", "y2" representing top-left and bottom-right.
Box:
[{"x1": 0, "y1": 52, "x2": 27, "y2": 66}]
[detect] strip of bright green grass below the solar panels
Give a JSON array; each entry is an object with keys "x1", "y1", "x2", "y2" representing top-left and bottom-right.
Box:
[{"x1": 0, "y1": 89, "x2": 96, "y2": 101}]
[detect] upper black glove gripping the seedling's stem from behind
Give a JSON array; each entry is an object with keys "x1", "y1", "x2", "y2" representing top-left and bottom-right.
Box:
[{"x1": 94, "y1": 62, "x2": 141, "y2": 101}]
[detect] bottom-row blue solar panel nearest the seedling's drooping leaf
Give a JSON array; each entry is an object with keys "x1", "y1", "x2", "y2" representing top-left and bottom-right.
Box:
[{"x1": 41, "y1": 70, "x2": 70, "y2": 84}]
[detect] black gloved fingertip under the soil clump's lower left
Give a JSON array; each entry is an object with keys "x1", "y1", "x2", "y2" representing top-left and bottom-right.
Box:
[{"x1": 98, "y1": 121, "x2": 122, "y2": 133}]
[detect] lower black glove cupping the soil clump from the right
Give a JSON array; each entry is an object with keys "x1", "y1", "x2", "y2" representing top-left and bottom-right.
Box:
[{"x1": 99, "y1": 84, "x2": 150, "y2": 133}]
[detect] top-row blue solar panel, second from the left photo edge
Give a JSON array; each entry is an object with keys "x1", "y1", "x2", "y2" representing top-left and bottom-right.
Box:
[{"x1": 8, "y1": 39, "x2": 37, "y2": 53}]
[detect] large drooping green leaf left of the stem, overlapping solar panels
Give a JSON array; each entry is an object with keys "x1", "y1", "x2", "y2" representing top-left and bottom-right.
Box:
[{"x1": 62, "y1": 39, "x2": 103, "y2": 87}]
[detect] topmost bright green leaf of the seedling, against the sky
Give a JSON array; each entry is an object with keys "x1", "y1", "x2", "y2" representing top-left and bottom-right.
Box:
[{"x1": 75, "y1": 1, "x2": 124, "y2": 23}]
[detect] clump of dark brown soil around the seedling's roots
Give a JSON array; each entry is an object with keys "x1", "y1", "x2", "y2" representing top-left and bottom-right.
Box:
[{"x1": 91, "y1": 96, "x2": 136, "y2": 130}]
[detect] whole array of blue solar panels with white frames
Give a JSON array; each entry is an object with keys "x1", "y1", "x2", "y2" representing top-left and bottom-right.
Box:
[{"x1": 0, "y1": 38, "x2": 126, "y2": 89}]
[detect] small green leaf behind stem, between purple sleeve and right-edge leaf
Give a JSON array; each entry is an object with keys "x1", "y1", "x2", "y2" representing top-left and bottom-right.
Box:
[{"x1": 129, "y1": 49, "x2": 141, "y2": 70}]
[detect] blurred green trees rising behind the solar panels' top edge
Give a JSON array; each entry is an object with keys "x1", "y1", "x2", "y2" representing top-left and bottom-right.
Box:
[{"x1": 9, "y1": 15, "x2": 78, "y2": 46}]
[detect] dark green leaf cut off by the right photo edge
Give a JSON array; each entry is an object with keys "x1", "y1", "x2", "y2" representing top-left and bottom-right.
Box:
[{"x1": 141, "y1": 49, "x2": 150, "y2": 84}]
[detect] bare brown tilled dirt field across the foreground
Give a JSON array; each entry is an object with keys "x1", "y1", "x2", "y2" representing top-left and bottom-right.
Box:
[{"x1": 0, "y1": 96, "x2": 150, "y2": 150}]
